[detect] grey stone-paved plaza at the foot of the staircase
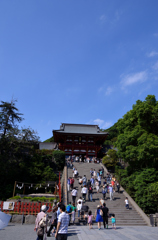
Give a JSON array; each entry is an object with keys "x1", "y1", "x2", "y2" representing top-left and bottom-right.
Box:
[{"x1": 0, "y1": 223, "x2": 158, "y2": 240}]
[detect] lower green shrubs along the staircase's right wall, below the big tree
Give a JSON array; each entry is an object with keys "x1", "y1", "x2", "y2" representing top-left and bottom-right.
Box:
[{"x1": 116, "y1": 167, "x2": 158, "y2": 214}]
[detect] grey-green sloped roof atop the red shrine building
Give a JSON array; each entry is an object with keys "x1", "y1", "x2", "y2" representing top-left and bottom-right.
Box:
[{"x1": 53, "y1": 123, "x2": 108, "y2": 135}]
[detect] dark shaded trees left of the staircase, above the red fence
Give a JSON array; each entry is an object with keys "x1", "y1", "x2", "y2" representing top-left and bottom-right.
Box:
[{"x1": 0, "y1": 100, "x2": 57, "y2": 199}]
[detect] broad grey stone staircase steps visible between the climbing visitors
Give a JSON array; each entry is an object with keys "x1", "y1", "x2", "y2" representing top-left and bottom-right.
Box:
[{"x1": 68, "y1": 162, "x2": 147, "y2": 226}]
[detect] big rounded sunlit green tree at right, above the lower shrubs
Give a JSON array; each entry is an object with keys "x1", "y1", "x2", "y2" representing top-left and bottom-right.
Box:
[{"x1": 116, "y1": 95, "x2": 158, "y2": 170}]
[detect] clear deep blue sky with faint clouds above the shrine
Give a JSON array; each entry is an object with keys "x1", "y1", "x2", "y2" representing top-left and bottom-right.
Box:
[{"x1": 0, "y1": 0, "x2": 158, "y2": 141}]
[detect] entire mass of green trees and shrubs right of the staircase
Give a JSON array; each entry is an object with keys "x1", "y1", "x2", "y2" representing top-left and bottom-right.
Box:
[{"x1": 115, "y1": 95, "x2": 158, "y2": 213}]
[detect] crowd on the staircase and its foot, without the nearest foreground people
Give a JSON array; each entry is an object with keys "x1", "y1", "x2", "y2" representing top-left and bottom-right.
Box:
[{"x1": 64, "y1": 166, "x2": 120, "y2": 229}]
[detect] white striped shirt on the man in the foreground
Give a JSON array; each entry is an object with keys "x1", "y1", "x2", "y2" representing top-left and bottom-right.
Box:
[{"x1": 58, "y1": 212, "x2": 70, "y2": 234}]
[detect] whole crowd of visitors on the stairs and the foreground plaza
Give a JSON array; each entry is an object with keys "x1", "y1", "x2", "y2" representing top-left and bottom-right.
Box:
[{"x1": 35, "y1": 162, "x2": 129, "y2": 240}]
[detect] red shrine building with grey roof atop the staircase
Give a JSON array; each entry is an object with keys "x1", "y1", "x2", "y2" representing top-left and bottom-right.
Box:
[{"x1": 53, "y1": 123, "x2": 108, "y2": 157}]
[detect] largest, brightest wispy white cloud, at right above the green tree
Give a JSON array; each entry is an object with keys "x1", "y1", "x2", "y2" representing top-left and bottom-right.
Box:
[{"x1": 121, "y1": 71, "x2": 147, "y2": 88}]
